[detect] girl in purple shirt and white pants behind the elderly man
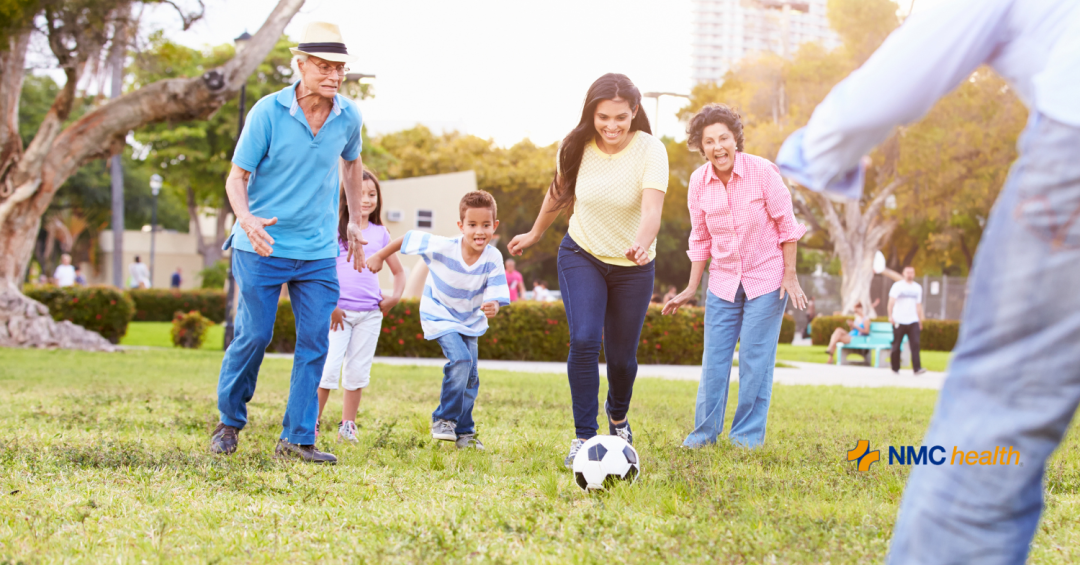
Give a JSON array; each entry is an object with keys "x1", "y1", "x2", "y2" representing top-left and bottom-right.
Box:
[{"x1": 315, "y1": 171, "x2": 405, "y2": 443}]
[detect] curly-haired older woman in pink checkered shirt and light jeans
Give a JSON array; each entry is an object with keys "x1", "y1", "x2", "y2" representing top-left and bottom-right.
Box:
[{"x1": 663, "y1": 104, "x2": 807, "y2": 447}]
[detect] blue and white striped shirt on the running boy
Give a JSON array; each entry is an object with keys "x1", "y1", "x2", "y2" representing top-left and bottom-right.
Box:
[{"x1": 401, "y1": 230, "x2": 510, "y2": 339}]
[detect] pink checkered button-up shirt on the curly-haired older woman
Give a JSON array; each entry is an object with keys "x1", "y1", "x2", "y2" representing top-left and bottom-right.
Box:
[{"x1": 686, "y1": 151, "x2": 807, "y2": 302}]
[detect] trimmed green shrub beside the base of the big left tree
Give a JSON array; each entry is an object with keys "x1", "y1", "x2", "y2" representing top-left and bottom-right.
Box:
[{"x1": 23, "y1": 285, "x2": 135, "y2": 344}]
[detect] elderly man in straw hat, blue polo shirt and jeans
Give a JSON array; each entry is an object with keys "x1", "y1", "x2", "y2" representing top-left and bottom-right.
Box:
[{"x1": 211, "y1": 23, "x2": 366, "y2": 463}]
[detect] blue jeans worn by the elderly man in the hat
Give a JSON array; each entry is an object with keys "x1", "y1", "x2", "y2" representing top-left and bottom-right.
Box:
[{"x1": 217, "y1": 248, "x2": 338, "y2": 445}]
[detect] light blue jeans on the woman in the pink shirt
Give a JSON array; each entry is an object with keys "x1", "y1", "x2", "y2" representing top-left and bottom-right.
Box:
[{"x1": 683, "y1": 284, "x2": 787, "y2": 447}]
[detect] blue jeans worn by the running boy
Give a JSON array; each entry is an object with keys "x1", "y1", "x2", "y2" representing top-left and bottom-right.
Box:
[{"x1": 431, "y1": 333, "x2": 480, "y2": 435}]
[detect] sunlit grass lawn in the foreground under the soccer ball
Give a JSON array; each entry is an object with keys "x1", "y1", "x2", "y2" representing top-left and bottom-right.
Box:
[{"x1": 0, "y1": 350, "x2": 1080, "y2": 563}]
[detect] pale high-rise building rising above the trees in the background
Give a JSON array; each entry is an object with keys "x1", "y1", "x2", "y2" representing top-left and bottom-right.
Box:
[{"x1": 690, "y1": 0, "x2": 840, "y2": 82}]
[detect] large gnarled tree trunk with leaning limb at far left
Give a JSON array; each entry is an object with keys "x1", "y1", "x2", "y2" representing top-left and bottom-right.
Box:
[{"x1": 0, "y1": 0, "x2": 305, "y2": 349}]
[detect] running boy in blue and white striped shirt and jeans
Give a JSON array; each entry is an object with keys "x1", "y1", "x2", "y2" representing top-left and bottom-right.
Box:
[{"x1": 367, "y1": 190, "x2": 510, "y2": 449}]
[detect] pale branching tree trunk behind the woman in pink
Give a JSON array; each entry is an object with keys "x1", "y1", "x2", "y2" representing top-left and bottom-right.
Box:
[{"x1": 810, "y1": 179, "x2": 901, "y2": 318}]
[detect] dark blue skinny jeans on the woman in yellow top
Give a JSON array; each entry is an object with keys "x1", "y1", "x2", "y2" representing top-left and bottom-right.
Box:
[{"x1": 558, "y1": 234, "x2": 656, "y2": 440}]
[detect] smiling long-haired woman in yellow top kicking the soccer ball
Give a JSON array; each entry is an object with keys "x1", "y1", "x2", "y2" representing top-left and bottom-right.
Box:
[{"x1": 508, "y1": 73, "x2": 667, "y2": 467}]
